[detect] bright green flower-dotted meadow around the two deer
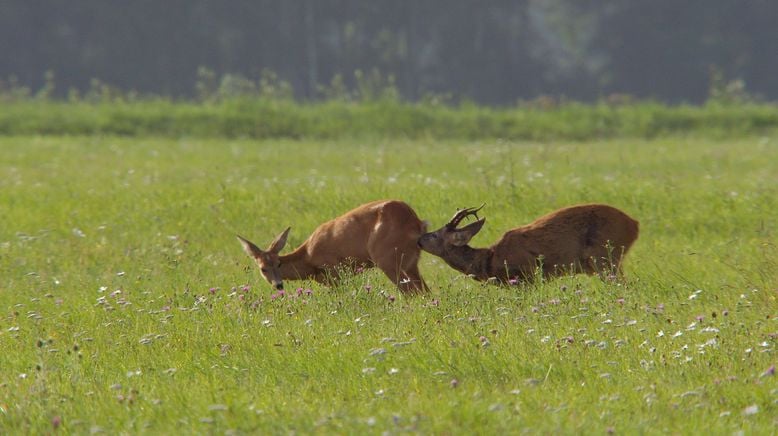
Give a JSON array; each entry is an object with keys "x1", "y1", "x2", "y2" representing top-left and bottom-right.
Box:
[{"x1": 0, "y1": 135, "x2": 778, "y2": 434}]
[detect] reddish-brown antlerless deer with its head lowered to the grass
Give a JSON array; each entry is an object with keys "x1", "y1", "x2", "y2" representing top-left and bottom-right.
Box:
[{"x1": 238, "y1": 200, "x2": 429, "y2": 293}]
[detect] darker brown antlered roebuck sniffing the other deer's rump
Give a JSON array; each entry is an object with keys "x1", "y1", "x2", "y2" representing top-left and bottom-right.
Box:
[{"x1": 419, "y1": 204, "x2": 638, "y2": 283}]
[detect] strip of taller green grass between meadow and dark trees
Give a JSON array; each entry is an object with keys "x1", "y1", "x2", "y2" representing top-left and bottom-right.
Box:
[{"x1": 0, "y1": 99, "x2": 778, "y2": 141}]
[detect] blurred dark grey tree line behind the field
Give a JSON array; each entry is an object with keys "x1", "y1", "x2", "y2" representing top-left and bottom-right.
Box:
[{"x1": 0, "y1": 0, "x2": 778, "y2": 104}]
